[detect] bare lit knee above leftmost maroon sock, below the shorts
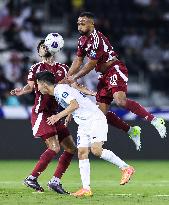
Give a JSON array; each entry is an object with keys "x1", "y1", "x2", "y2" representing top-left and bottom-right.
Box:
[{"x1": 45, "y1": 135, "x2": 60, "y2": 153}]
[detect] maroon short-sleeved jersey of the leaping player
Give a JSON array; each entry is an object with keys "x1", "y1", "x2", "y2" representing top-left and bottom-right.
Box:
[{"x1": 77, "y1": 29, "x2": 117, "y2": 72}]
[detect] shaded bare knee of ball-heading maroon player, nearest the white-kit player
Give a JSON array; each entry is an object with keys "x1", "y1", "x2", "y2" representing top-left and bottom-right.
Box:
[{"x1": 60, "y1": 135, "x2": 76, "y2": 154}]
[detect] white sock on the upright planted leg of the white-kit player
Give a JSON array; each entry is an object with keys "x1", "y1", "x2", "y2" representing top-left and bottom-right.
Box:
[{"x1": 79, "y1": 159, "x2": 90, "y2": 190}]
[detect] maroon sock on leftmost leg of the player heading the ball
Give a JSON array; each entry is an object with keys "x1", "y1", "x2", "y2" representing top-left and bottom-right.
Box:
[{"x1": 31, "y1": 149, "x2": 56, "y2": 177}]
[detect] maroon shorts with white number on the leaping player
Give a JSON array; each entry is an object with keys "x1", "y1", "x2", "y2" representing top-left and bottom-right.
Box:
[{"x1": 96, "y1": 61, "x2": 128, "y2": 105}]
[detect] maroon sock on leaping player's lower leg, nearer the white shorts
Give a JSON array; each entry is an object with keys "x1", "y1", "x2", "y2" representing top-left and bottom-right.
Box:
[{"x1": 106, "y1": 112, "x2": 130, "y2": 132}]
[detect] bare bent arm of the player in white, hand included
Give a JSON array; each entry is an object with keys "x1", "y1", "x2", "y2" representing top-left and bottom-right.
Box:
[{"x1": 47, "y1": 99, "x2": 79, "y2": 125}]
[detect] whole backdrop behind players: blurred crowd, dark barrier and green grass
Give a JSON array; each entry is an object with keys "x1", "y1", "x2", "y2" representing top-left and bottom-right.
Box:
[{"x1": 0, "y1": 0, "x2": 169, "y2": 205}]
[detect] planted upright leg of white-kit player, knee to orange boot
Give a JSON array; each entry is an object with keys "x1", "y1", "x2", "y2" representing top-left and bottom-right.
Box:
[{"x1": 72, "y1": 147, "x2": 93, "y2": 197}]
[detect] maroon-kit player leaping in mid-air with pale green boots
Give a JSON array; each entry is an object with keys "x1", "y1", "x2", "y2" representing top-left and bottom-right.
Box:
[{"x1": 68, "y1": 12, "x2": 166, "y2": 143}]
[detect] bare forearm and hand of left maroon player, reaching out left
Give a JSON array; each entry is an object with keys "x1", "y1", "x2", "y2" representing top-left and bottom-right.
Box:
[{"x1": 10, "y1": 81, "x2": 34, "y2": 96}]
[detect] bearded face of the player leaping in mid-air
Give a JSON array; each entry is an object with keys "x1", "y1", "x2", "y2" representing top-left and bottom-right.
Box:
[{"x1": 77, "y1": 16, "x2": 94, "y2": 36}]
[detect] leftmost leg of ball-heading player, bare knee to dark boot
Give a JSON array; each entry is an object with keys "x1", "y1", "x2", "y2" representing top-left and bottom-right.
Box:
[{"x1": 24, "y1": 135, "x2": 60, "y2": 192}]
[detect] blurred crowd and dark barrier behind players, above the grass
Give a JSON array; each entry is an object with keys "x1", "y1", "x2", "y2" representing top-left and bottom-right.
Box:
[{"x1": 0, "y1": 0, "x2": 169, "y2": 159}]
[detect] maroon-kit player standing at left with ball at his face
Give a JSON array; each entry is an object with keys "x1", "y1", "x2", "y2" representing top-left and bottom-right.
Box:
[{"x1": 11, "y1": 40, "x2": 76, "y2": 194}]
